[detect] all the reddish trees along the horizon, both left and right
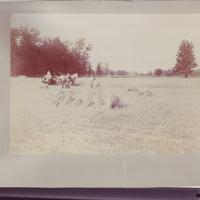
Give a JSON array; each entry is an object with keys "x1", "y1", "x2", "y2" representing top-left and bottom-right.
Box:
[{"x1": 11, "y1": 26, "x2": 197, "y2": 77}]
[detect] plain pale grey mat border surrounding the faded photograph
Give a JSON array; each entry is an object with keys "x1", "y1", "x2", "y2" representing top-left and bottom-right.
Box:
[{"x1": 0, "y1": 0, "x2": 200, "y2": 187}]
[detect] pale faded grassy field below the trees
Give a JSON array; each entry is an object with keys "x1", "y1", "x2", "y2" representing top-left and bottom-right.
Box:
[{"x1": 10, "y1": 78, "x2": 200, "y2": 154}]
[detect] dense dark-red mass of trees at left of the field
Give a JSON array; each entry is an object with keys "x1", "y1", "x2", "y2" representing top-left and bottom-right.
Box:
[{"x1": 11, "y1": 27, "x2": 92, "y2": 77}]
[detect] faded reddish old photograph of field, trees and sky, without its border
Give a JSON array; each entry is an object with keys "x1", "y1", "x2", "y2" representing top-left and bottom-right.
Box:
[{"x1": 10, "y1": 14, "x2": 200, "y2": 155}]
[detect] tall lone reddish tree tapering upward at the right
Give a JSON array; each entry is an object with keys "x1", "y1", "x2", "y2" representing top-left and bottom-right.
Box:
[{"x1": 173, "y1": 40, "x2": 197, "y2": 77}]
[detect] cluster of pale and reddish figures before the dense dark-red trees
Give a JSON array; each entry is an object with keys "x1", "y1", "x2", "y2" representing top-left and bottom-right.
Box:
[{"x1": 42, "y1": 71, "x2": 78, "y2": 88}]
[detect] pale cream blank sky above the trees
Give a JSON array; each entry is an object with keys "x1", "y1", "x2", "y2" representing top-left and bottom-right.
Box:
[{"x1": 11, "y1": 14, "x2": 200, "y2": 72}]
